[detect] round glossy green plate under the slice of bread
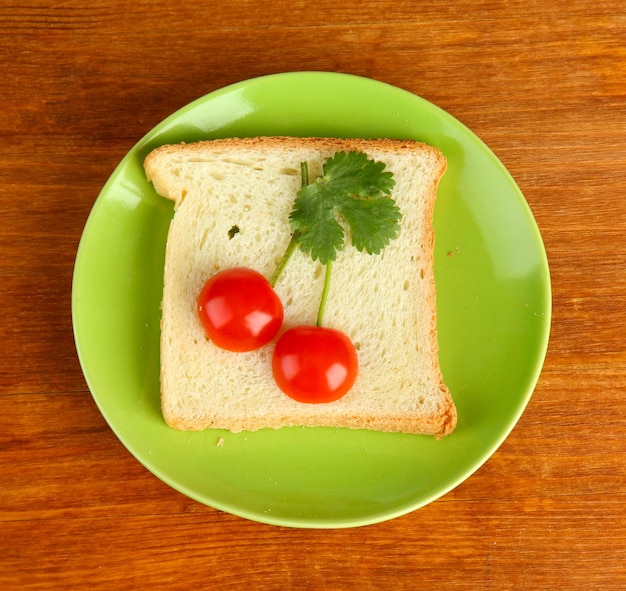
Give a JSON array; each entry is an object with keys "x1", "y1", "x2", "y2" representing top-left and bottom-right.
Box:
[{"x1": 72, "y1": 72, "x2": 551, "y2": 528}]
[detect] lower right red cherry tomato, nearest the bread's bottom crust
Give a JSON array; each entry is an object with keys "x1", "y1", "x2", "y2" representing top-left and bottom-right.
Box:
[{"x1": 272, "y1": 326, "x2": 359, "y2": 403}]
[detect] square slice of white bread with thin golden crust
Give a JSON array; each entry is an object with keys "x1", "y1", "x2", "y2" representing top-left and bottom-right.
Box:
[{"x1": 144, "y1": 137, "x2": 456, "y2": 436}]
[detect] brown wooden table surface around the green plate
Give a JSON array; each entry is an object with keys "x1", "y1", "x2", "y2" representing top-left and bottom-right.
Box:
[{"x1": 0, "y1": 0, "x2": 626, "y2": 591}]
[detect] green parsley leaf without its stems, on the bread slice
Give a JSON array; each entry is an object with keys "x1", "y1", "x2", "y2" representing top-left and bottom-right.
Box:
[{"x1": 289, "y1": 152, "x2": 402, "y2": 264}]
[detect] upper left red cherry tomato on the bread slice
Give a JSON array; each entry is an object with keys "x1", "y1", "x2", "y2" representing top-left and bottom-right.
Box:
[{"x1": 198, "y1": 267, "x2": 283, "y2": 352}]
